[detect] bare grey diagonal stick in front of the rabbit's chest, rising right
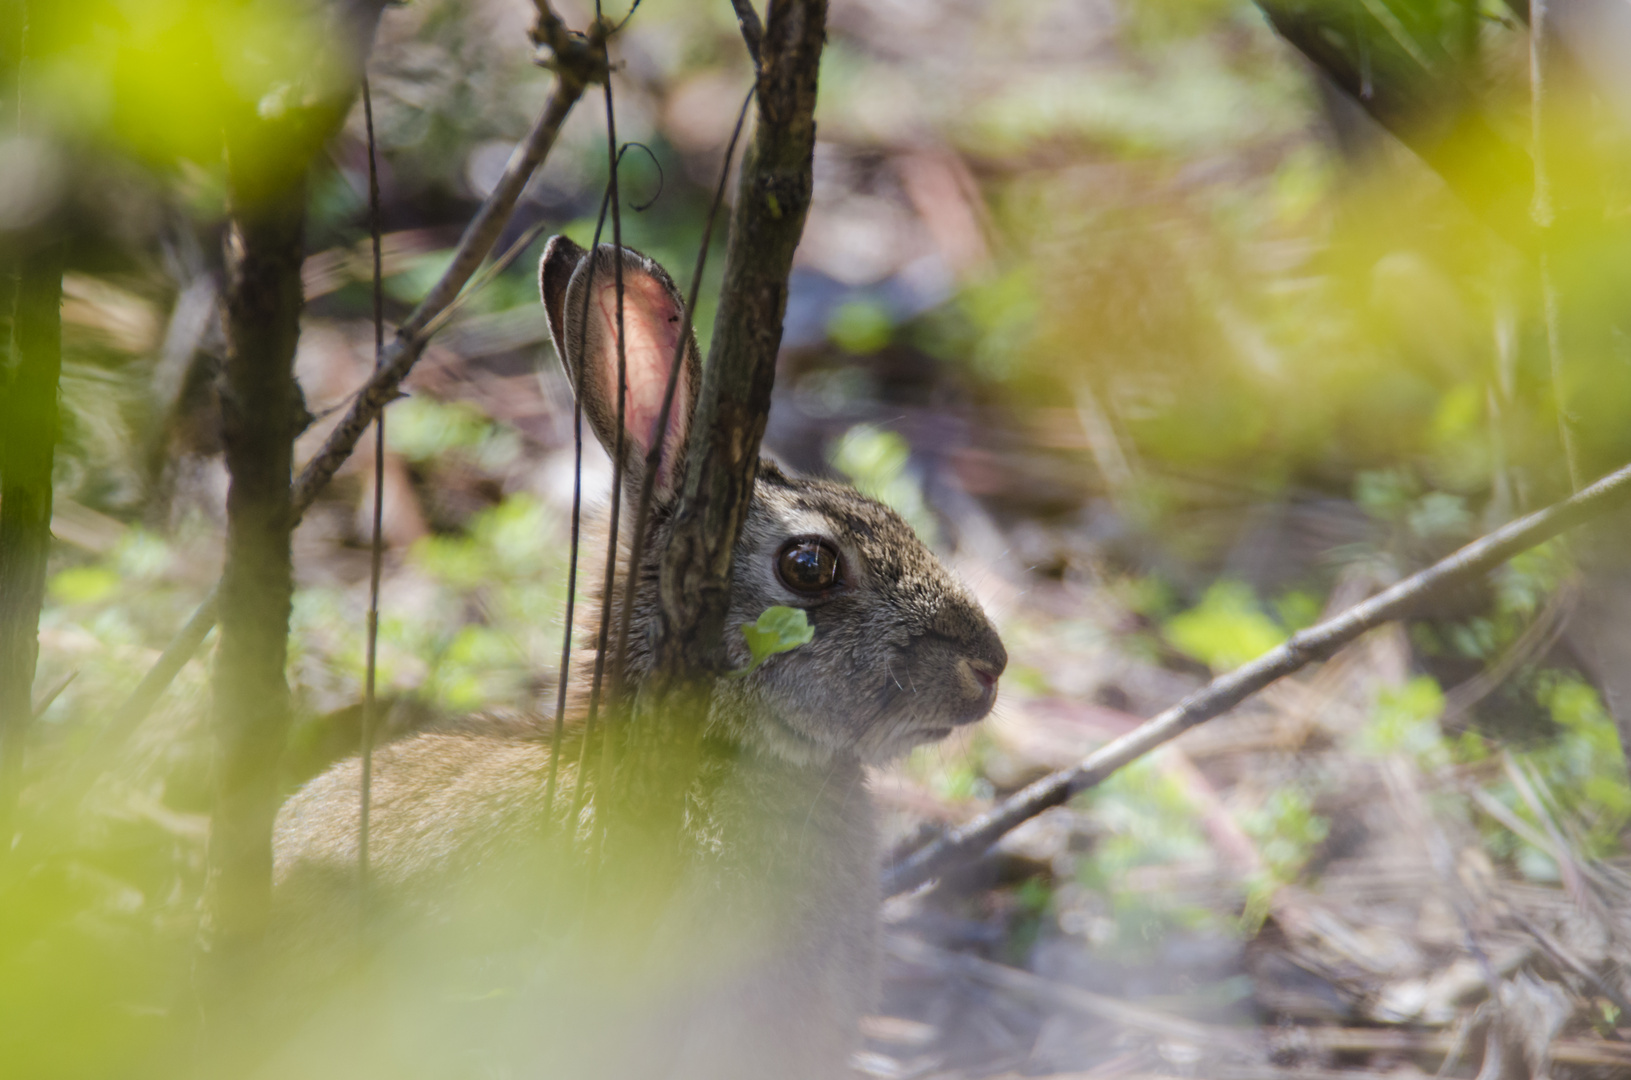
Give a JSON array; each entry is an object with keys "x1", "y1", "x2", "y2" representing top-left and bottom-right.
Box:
[{"x1": 884, "y1": 465, "x2": 1631, "y2": 896}]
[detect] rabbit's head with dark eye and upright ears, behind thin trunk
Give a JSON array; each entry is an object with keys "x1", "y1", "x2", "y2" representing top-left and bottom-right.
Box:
[{"x1": 540, "y1": 237, "x2": 1008, "y2": 765}]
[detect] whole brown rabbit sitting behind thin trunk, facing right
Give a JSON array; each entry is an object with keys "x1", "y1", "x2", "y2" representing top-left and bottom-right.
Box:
[{"x1": 274, "y1": 237, "x2": 1008, "y2": 1080}]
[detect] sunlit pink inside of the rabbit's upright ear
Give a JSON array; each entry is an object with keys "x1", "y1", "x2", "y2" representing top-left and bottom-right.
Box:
[{"x1": 599, "y1": 274, "x2": 692, "y2": 488}]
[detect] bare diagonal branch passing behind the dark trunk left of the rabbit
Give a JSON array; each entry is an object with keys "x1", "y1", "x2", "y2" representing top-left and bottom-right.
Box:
[{"x1": 104, "y1": 29, "x2": 605, "y2": 744}]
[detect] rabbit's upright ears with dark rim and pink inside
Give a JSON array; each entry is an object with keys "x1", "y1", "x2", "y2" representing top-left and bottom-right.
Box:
[{"x1": 538, "y1": 237, "x2": 701, "y2": 501}]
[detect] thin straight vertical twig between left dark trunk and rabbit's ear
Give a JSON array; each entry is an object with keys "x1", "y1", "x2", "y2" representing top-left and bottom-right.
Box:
[{"x1": 357, "y1": 75, "x2": 385, "y2": 933}]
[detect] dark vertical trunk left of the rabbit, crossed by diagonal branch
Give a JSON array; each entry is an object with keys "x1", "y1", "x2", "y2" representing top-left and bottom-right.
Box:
[{"x1": 209, "y1": 153, "x2": 305, "y2": 959}]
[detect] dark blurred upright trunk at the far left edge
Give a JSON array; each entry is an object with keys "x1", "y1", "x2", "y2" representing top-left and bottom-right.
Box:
[{"x1": 0, "y1": 241, "x2": 64, "y2": 855}]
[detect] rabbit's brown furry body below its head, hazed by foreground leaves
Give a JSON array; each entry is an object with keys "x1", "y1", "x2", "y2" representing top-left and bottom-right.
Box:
[{"x1": 276, "y1": 733, "x2": 877, "y2": 1080}]
